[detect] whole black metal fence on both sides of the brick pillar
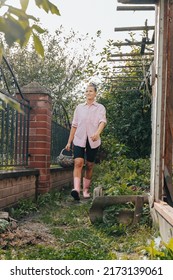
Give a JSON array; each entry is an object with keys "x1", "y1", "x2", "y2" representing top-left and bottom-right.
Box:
[{"x1": 0, "y1": 57, "x2": 70, "y2": 167}]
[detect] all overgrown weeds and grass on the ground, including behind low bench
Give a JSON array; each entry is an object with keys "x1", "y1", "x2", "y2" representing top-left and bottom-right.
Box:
[{"x1": 0, "y1": 158, "x2": 164, "y2": 260}]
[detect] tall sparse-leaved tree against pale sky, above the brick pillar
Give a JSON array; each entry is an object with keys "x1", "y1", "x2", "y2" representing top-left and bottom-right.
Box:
[{"x1": 5, "y1": 26, "x2": 98, "y2": 122}]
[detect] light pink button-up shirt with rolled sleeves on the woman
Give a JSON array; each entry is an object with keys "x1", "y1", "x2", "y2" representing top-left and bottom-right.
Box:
[{"x1": 72, "y1": 102, "x2": 106, "y2": 149}]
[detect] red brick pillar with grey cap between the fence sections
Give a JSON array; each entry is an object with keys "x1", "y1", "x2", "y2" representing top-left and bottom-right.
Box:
[{"x1": 22, "y1": 82, "x2": 52, "y2": 193}]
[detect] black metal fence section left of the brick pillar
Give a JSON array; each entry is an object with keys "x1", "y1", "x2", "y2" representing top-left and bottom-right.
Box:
[{"x1": 0, "y1": 57, "x2": 30, "y2": 167}]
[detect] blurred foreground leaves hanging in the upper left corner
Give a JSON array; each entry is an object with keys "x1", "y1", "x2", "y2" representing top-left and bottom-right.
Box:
[{"x1": 0, "y1": 0, "x2": 60, "y2": 61}]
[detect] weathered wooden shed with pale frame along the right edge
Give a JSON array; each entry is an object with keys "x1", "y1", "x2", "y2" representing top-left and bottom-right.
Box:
[{"x1": 118, "y1": 0, "x2": 173, "y2": 242}]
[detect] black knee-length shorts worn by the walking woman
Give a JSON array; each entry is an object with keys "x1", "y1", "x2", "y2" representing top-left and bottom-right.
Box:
[{"x1": 74, "y1": 139, "x2": 99, "y2": 162}]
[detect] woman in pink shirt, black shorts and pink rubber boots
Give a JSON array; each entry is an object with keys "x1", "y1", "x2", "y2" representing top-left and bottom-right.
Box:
[{"x1": 65, "y1": 83, "x2": 106, "y2": 200}]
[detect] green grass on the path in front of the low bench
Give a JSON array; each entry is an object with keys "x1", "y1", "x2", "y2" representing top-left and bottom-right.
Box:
[{"x1": 0, "y1": 190, "x2": 156, "y2": 260}]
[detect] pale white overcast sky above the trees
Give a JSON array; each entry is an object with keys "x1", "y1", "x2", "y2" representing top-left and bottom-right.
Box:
[{"x1": 26, "y1": 0, "x2": 155, "y2": 52}]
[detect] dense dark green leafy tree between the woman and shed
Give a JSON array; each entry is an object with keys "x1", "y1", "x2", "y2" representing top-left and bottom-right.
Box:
[{"x1": 96, "y1": 36, "x2": 151, "y2": 158}]
